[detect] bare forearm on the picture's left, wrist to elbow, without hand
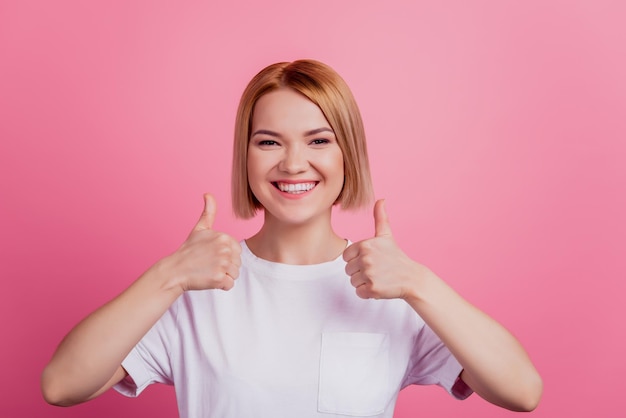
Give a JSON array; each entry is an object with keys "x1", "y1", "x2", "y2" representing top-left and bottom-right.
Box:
[{"x1": 42, "y1": 260, "x2": 182, "y2": 405}]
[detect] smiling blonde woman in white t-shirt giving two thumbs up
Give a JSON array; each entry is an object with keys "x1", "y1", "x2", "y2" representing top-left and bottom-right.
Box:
[{"x1": 42, "y1": 60, "x2": 542, "y2": 417}]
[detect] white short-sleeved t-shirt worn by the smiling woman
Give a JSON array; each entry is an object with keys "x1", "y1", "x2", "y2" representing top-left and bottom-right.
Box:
[{"x1": 115, "y1": 241, "x2": 471, "y2": 418}]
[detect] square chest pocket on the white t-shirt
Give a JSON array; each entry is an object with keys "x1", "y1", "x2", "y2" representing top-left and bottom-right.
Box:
[{"x1": 318, "y1": 332, "x2": 391, "y2": 417}]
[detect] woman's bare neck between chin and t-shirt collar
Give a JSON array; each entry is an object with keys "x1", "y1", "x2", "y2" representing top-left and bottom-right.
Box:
[{"x1": 246, "y1": 212, "x2": 347, "y2": 265}]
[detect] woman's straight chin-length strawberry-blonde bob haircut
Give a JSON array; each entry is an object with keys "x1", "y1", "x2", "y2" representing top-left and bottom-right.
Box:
[{"x1": 231, "y1": 60, "x2": 374, "y2": 219}]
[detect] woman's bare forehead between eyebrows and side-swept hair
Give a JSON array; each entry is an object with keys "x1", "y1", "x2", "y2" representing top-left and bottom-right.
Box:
[{"x1": 252, "y1": 88, "x2": 330, "y2": 130}]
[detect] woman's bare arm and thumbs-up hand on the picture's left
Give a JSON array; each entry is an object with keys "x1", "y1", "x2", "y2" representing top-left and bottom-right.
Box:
[{"x1": 41, "y1": 195, "x2": 241, "y2": 406}]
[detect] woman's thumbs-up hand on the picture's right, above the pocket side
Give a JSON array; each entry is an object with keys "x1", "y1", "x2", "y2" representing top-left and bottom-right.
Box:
[{"x1": 343, "y1": 200, "x2": 425, "y2": 299}]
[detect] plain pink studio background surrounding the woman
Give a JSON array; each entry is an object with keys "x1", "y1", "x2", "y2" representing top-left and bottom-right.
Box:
[{"x1": 0, "y1": 0, "x2": 626, "y2": 418}]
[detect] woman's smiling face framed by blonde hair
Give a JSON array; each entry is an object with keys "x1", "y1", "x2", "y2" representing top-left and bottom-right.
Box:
[{"x1": 248, "y1": 88, "x2": 344, "y2": 224}]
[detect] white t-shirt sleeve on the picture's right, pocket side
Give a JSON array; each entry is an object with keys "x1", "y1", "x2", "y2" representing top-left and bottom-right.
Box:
[{"x1": 403, "y1": 325, "x2": 472, "y2": 399}]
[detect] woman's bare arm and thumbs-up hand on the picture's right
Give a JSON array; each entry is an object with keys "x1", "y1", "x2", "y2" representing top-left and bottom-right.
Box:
[{"x1": 344, "y1": 201, "x2": 543, "y2": 411}]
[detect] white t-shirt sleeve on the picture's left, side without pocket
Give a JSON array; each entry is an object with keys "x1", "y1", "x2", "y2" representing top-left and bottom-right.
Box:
[{"x1": 113, "y1": 307, "x2": 176, "y2": 397}]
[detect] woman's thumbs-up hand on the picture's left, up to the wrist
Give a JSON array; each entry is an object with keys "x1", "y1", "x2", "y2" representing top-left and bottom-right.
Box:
[{"x1": 166, "y1": 194, "x2": 241, "y2": 291}]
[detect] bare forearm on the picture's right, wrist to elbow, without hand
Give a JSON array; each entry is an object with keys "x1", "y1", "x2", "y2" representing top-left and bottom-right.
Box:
[{"x1": 405, "y1": 267, "x2": 542, "y2": 411}]
